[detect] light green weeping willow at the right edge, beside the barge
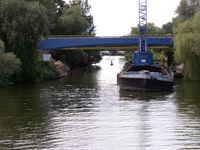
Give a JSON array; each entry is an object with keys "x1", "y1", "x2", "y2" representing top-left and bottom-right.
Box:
[{"x1": 175, "y1": 11, "x2": 200, "y2": 80}]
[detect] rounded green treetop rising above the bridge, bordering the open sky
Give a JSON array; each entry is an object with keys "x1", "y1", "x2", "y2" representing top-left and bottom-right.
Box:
[{"x1": 53, "y1": 0, "x2": 95, "y2": 35}]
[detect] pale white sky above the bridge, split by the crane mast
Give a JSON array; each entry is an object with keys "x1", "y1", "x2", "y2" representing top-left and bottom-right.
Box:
[{"x1": 66, "y1": 0, "x2": 180, "y2": 36}]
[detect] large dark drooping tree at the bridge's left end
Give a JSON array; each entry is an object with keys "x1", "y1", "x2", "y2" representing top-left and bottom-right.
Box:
[{"x1": 0, "y1": 0, "x2": 51, "y2": 81}]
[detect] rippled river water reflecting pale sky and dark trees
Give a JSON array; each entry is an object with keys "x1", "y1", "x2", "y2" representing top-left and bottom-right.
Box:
[{"x1": 0, "y1": 56, "x2": 200, "y2": 150}]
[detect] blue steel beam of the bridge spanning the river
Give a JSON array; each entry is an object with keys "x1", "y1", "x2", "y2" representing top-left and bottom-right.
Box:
[{"x1": 38, "y1": 37, "x2": 174, "y2": 51}]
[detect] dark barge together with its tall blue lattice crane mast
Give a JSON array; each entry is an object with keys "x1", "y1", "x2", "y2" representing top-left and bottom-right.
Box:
[{"x1": 117, "y1": 0, "x2": 174, "y2": 91}]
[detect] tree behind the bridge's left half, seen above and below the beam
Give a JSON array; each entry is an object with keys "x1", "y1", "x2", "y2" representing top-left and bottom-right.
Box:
[{"x1": 50, "y1": 0, "x2": 101, "y2": 69}]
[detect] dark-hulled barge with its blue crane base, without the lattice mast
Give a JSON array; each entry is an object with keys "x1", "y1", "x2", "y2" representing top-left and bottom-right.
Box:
[{"x1": 117, "y1": 52, "x2": 174, "y2": 91}]
